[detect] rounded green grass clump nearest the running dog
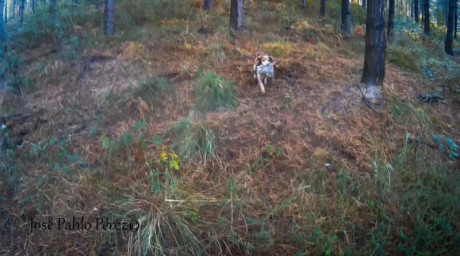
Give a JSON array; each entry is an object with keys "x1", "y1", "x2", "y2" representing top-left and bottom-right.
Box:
[{"x1": 195, "y1": 72, "x2": 238, "y2": 111}]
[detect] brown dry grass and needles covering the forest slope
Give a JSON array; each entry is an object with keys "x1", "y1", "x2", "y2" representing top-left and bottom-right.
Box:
[{"x1": 0, "y1": 3, "x2": 460, "y2": 255}]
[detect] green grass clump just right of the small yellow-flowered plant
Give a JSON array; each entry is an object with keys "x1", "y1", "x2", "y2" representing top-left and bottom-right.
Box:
[{"x1": 170, "y1": 119, "x2": 216, "y2": 161}]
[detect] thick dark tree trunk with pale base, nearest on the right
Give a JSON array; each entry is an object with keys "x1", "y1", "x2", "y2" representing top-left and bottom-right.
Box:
[{"x1": 361, "y1": 0, "x2": 386, "y2": 100}]
